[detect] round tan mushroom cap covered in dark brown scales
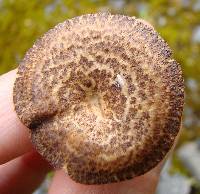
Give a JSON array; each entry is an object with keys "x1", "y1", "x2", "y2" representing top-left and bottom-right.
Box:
[{"x1": 14, "y1": 14, "x2": 184, "y2": 184}]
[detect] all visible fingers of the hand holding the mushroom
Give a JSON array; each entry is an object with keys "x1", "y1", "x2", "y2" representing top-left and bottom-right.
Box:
[{"x1": 0, "y1": 70, "x2": 178, "y2": 194}]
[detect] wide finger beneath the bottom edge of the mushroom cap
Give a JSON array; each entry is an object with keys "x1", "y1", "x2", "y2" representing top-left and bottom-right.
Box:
[{"x1": 49, "y1": 166, "x2": 160, "y2": 194}]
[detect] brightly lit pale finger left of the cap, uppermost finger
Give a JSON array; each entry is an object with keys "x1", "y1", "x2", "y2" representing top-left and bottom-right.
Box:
[{"x1": 0, "y1": 70, "x2": 32, "y2": 164}]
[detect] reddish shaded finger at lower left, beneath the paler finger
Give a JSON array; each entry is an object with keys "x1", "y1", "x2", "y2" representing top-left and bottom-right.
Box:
[{"x1": 0, "y1": 151, "x2": 51, "y2": 194}]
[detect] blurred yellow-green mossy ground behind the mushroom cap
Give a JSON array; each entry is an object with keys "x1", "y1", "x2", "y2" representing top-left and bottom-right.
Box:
[{"x1": 0, "y1": 0, "x2": 200, "y2": 191}]
